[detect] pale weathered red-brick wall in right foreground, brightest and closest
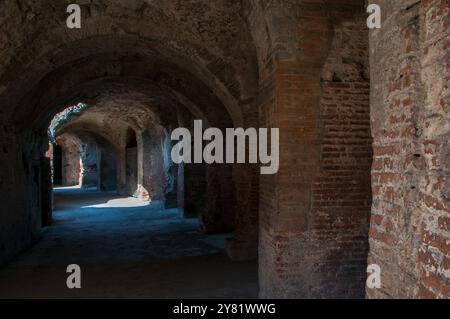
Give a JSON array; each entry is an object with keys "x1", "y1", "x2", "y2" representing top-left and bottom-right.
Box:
[{"x1": 367, "y1": 0, "x2": 450, "y2": 298}]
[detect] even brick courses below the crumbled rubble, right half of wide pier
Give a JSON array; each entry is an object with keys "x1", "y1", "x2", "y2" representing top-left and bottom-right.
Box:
[{"x1": 309, "y1": 82, "x2": 372, "y2": 297}]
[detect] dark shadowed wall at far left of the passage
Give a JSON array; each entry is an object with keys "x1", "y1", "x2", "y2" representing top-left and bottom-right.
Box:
[{"x1": 0, "y1": 126, "x2": 44, "y2": 264}]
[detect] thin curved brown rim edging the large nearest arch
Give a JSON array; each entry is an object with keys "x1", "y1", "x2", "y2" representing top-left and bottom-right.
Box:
[{"x1": 0, "y1": 22, "x2": 255, "y2": 126}]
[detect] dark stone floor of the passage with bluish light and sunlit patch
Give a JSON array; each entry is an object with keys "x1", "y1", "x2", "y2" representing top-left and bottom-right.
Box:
[{"x1": 0, "y1": 188, "x2": 258, "y2": 298}]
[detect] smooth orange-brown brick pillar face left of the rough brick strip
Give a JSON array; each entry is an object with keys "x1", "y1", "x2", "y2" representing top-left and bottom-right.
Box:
[{"x1": 259, "y1": 62, "x2": 321, "y2": 297}]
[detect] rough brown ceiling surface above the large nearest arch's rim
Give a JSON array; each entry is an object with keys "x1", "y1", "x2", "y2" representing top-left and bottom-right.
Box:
[{"x1": 0, "y1": 0, "x2": 256, "y2": 100}]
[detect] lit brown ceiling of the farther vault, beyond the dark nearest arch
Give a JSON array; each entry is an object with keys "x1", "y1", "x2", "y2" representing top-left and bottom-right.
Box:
[{"x1": 50, "y1": 77, "x2": 178, "y2": 136}]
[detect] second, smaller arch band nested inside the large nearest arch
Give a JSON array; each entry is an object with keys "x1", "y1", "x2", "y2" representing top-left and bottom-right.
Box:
[{"x1": 33, "y1": 76, "x2": 213, "y2": 131}]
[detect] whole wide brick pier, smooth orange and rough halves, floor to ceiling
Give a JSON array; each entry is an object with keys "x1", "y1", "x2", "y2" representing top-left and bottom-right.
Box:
[{"x1": 249, "y1": 1, "x2": 371, "y2": 298}]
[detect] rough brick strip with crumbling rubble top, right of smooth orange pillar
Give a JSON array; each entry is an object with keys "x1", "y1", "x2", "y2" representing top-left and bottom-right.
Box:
[{"x1": 308, "y1": 17, "x2": 372, "y2": 298}]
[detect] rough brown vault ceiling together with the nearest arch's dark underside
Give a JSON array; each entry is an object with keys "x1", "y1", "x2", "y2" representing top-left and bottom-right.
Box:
[{"x1": 0, "y1": 0, "x2": 257, "y2": 129}]
